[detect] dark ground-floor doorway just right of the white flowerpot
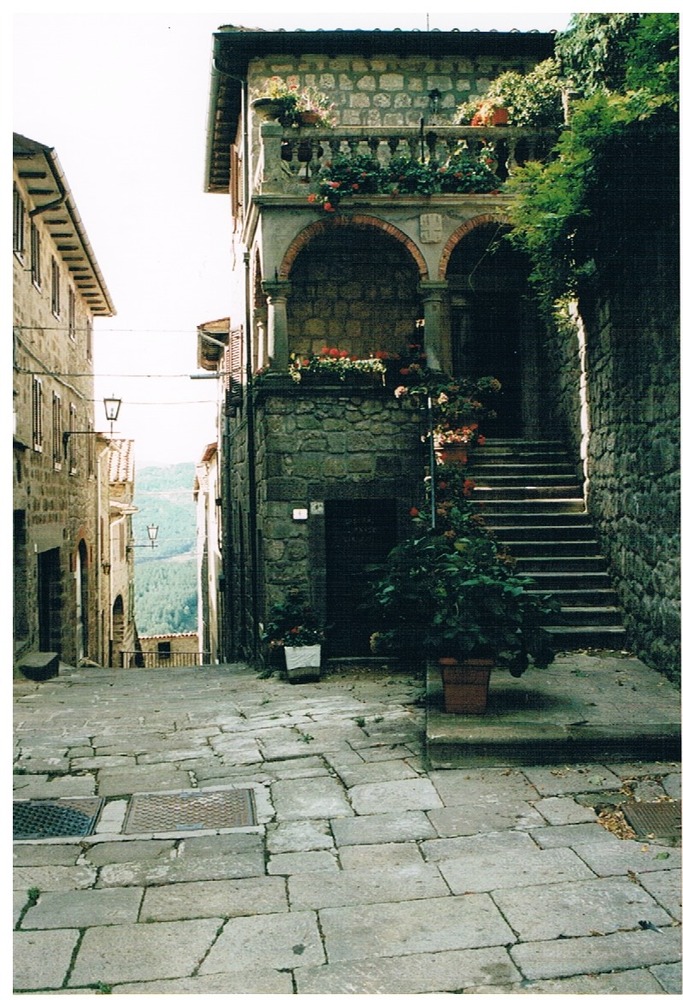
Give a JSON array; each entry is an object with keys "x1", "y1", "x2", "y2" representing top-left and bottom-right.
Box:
[{"x1": 325, "y1": 500, "x2": 396, "y2": 656}]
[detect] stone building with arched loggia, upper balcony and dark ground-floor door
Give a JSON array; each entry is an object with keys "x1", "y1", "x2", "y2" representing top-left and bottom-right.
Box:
[{"x1": 206, "y1": 26, "x2": 675, "y2": 676}]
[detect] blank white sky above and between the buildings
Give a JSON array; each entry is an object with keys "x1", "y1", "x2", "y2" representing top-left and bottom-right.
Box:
[{"x1": 8, "y1": 0, "x2": 584, "y2": 466}]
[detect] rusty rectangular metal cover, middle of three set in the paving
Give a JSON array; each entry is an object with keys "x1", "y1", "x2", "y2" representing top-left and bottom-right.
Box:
[{"x1": 123, "y1": 788, "x2": 256, "y2": 833}]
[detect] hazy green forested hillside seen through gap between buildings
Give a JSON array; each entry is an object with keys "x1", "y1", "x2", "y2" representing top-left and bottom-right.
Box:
[{"x1": 133, "y1": 462, "x2": 197, "y2": 635}]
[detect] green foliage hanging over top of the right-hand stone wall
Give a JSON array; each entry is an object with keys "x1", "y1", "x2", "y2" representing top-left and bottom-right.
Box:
[{"x1": 506, "y1": 14, "x2": 678, "y2": 309}]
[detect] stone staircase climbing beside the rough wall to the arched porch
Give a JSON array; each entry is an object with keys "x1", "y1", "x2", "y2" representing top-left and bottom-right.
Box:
[{"x1": 467, "y1": 438, "x2": 626, "y2": 650}]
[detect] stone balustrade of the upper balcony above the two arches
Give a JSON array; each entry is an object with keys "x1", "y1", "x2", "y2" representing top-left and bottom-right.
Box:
[{"x1": 251, "y1": 122, "x2": 558, "y2": 203}]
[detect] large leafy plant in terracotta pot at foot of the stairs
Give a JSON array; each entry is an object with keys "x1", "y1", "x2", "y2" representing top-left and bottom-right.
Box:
[{"x1": 373, "y1": 468, "x2": 557, "y2": 714}]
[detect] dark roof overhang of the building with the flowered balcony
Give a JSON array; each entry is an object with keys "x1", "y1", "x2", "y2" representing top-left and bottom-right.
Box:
[{"x1": 205, "y1": 25, "x2": 555, "y2": 193}]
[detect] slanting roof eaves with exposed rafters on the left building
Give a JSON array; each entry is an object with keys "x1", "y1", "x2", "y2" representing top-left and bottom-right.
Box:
[{"x1": 13, "y1": 132, "x2": 116, "y2": 316}]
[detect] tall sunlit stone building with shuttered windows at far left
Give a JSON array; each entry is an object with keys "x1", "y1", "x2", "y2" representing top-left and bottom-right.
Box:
[{"x1": 13, "y1": 134, "x2": 114, "y2": 664}]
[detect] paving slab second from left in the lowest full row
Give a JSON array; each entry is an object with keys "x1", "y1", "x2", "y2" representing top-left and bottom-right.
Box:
[{"x1": 68, "y1": 919, "x2": 223, "y2": 986}]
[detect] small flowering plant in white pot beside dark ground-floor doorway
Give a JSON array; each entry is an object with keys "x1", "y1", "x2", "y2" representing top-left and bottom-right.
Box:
[{"x1": 262, "y1": 589, "x2": 325, "y2": 681}]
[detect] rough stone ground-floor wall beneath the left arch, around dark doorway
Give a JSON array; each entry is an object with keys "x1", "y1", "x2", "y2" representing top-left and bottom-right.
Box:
[{"x1": 226, "y1": 376, "x2": 425, "y2": 647}]
